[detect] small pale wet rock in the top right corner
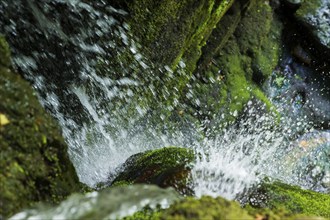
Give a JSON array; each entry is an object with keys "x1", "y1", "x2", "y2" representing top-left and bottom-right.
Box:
[{"x1": 295, "y1": 0, "x2": 330, "y2": 50}]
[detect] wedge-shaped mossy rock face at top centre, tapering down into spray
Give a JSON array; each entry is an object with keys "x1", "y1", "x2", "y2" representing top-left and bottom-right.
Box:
[{"x1": 118, "y1": 0, "x2": 234, "y2": 111}]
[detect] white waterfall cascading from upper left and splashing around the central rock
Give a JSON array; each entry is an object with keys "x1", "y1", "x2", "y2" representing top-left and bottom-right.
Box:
[{"x1": 0, "y1": 0, "x2": 330, "y2": 199}]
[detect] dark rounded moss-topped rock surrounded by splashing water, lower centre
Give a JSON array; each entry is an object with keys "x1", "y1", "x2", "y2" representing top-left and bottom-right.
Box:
[{"x1": 111, "y1": 147, "x2": 195, "y2": 194}]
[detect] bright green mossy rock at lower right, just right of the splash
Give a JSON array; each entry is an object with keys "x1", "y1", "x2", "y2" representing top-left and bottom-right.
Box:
[{"x1": 243, "y1": 182, "x2": 330, "y2": 218}]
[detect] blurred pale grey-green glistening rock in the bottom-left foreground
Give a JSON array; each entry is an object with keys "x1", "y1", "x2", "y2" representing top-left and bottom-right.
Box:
[{"x1": 11, "y1": 185, "x2": 182, "y2": 220}]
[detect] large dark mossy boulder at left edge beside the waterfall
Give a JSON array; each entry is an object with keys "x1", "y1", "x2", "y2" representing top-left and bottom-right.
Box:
[{"x1": 0, "y1": 37, "x2": 79, "y2": 217}]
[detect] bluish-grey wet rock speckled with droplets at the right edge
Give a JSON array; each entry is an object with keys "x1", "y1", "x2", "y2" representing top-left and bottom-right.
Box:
[{"x1": 265, "y1": 53, "x2": 330, "y2": 129}]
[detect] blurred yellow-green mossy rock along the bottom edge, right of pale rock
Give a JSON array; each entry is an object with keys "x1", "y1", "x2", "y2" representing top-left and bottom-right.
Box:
[{"x1": 125, "y1": 189, "x2": 326, "y2": 220}]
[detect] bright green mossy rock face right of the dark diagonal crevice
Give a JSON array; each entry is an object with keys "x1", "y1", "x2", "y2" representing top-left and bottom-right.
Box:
[{"x1": 183, "y1": 0, "x2": 282, "y2": 129}]
